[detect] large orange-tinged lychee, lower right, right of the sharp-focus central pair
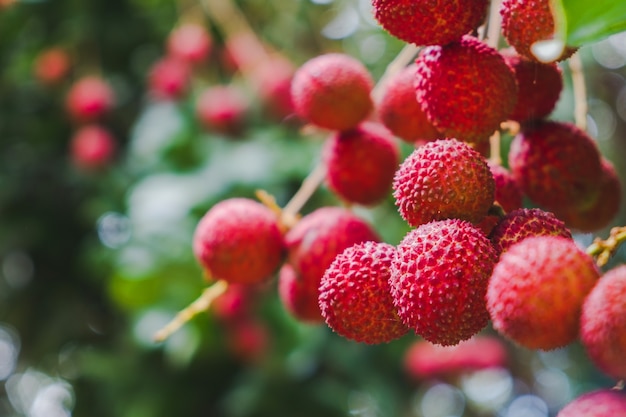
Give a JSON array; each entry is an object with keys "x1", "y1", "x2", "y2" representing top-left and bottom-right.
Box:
[{"x1": 487, "y1": 236, "x2": 600, "y2": 350}]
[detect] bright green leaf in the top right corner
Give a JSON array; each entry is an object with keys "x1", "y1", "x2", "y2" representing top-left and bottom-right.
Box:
[{"x1": 551, "y1": 0, "x2": 626, "y2": 46}]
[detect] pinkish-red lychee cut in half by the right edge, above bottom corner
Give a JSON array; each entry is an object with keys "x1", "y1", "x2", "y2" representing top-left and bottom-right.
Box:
[{"x1": 580, "y1": 265, "x2": 626, "y2": 380}]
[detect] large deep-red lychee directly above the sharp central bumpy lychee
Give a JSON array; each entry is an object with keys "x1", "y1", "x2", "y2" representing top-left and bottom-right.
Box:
[{"x1": 415, "y1": 36, "x2": 518, "y2": 142}]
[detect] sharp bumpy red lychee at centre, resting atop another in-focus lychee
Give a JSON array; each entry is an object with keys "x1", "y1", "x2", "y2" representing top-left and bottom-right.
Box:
[{"x1": 393, "y1": 139, "x2": 495, "y2": 227}]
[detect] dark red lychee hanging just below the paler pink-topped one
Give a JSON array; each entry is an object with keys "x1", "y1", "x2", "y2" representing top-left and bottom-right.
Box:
[{"x1": 324, "y1": 122, "x2": 400, "y2": 206}]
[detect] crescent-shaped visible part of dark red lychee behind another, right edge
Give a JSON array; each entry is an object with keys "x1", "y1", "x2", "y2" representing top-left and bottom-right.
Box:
[{"x1": 555, "y1": 158, "x2": 622, "y2": 233}]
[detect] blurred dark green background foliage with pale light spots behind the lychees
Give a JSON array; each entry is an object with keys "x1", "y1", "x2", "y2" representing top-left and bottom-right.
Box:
[{"x1": 0, "y1": 0, "x2": 626, "y2": 417}]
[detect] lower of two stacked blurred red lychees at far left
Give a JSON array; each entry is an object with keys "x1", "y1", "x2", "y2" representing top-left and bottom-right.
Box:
[{"x1": 70, "y1": 124, "x2": 117, "y2": 169}]
